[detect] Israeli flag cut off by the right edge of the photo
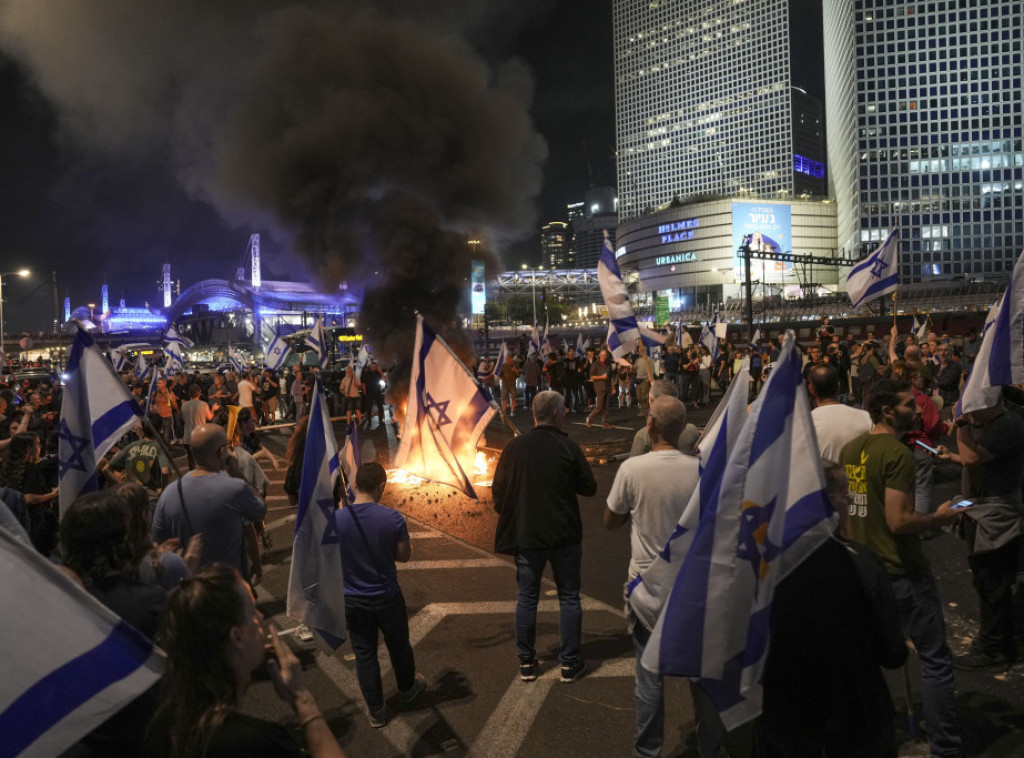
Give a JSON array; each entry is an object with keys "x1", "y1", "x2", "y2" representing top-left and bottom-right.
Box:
[{"x1": 953, "y1": 246, "x2": 1024, "y2": 417}]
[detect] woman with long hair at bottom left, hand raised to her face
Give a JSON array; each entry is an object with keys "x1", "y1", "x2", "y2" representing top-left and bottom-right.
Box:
[{"x1": 147, "y1": 563, "x2": 344, "y2": 758}]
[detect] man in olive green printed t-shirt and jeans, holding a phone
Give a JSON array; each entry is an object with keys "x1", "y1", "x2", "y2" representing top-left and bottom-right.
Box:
[{"x1": 840, "y1": 379, "x2": 964, "y2": 757}]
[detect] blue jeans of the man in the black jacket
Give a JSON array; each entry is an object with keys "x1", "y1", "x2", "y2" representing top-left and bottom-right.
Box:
[{"x1": 515, "y1": 545, "x2": 583, "y2": 666}]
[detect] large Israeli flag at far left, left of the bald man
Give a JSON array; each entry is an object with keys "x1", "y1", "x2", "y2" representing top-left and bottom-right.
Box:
[{"x1": 57, "y1": 329, "x2": 142, "y2": 515}]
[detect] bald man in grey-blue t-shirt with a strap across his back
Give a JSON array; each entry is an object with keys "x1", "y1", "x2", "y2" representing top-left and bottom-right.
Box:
[{"x1": 153, "y1": 424, "x2": 266, "y2": 579}]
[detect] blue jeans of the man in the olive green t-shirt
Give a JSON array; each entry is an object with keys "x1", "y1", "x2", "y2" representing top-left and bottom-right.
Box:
[{"x1": 890, "y1": 572, "x2": 964, "y2": 756}]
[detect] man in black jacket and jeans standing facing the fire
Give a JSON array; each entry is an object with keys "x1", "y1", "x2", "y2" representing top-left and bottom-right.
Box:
[{"x1": 492, "y1": 391, "x2": 597, "y2": 682}]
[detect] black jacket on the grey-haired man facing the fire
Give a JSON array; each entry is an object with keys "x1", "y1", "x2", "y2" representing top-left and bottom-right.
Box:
[{"x1": 492, "y1": 425, "x2": 597, "y2": 554}]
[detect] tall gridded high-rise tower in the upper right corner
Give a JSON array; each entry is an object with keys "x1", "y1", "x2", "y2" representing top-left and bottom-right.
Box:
[{"x1": 824, "y1": 0, "x2": 1024, "y2": 282}]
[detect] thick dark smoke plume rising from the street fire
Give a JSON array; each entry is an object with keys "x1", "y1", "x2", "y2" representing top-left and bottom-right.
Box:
[{"x1": 0, "y1": 0, "x2": 547, "y2": 356}]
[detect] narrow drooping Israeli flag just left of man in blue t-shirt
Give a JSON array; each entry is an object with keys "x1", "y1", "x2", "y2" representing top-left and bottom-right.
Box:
[{"x1": 286, "y1": 379, "x2": 346, "y2": 651}]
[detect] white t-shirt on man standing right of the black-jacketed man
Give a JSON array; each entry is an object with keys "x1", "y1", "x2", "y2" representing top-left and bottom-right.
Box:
[{"x1": 608, "y1": 450, "x2": 699, "y2": 580}]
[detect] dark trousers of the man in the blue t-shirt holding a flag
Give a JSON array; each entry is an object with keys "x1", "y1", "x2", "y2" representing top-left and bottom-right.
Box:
[{"x1": 345, "y1": 592, "x2": 416, "y2": 711}]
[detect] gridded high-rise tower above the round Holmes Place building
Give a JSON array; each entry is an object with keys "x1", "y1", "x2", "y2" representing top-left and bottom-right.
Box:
[{"x1": 613, "y1": 0, "x2": 824, "y2": 221}]
